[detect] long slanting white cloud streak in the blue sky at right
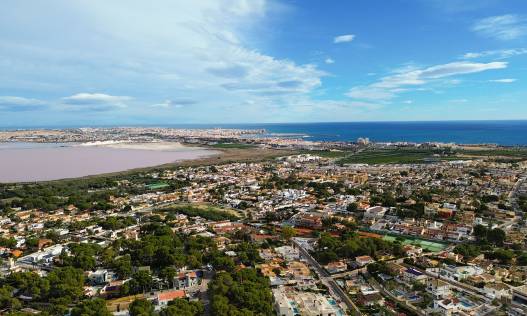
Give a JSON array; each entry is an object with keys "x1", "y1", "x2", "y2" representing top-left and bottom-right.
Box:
[{"x1": 347, "y1": 62, "x2": 507, "y2": 101}]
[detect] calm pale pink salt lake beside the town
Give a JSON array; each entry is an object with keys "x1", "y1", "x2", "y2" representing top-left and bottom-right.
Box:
[{"x1": 0, "y1": 143, "x2": 217, "y2": 182}]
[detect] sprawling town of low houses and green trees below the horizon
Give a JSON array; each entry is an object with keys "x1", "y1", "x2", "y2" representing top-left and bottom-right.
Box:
[{"x1": 0, "y1": 135, "x2": 527, "y2": 316}]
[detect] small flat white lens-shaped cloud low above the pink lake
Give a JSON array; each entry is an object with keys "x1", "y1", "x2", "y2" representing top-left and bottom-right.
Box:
[{"x1": 62, "y1": 93, "x2": 133, "y2": 111}]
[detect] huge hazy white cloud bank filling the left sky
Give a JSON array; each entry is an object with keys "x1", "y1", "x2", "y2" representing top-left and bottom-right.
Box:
[{"x1": 0, "y1": 0, "x2": 327, "y2": 120}]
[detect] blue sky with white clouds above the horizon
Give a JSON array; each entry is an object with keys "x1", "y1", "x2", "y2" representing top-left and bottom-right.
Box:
[{"x1": 0, "y1": 0, "x2": 527, "y2": 127}]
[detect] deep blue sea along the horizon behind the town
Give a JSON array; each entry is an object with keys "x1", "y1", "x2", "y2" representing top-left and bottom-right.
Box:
[{"x1": 0, "y1": 120, "x2": 527, "y2": 146}]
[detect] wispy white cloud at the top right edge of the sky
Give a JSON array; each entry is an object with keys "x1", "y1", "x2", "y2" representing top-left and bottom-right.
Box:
[{"x1": 472, "y1": 14, "x2": 527, "y2": 41}]
